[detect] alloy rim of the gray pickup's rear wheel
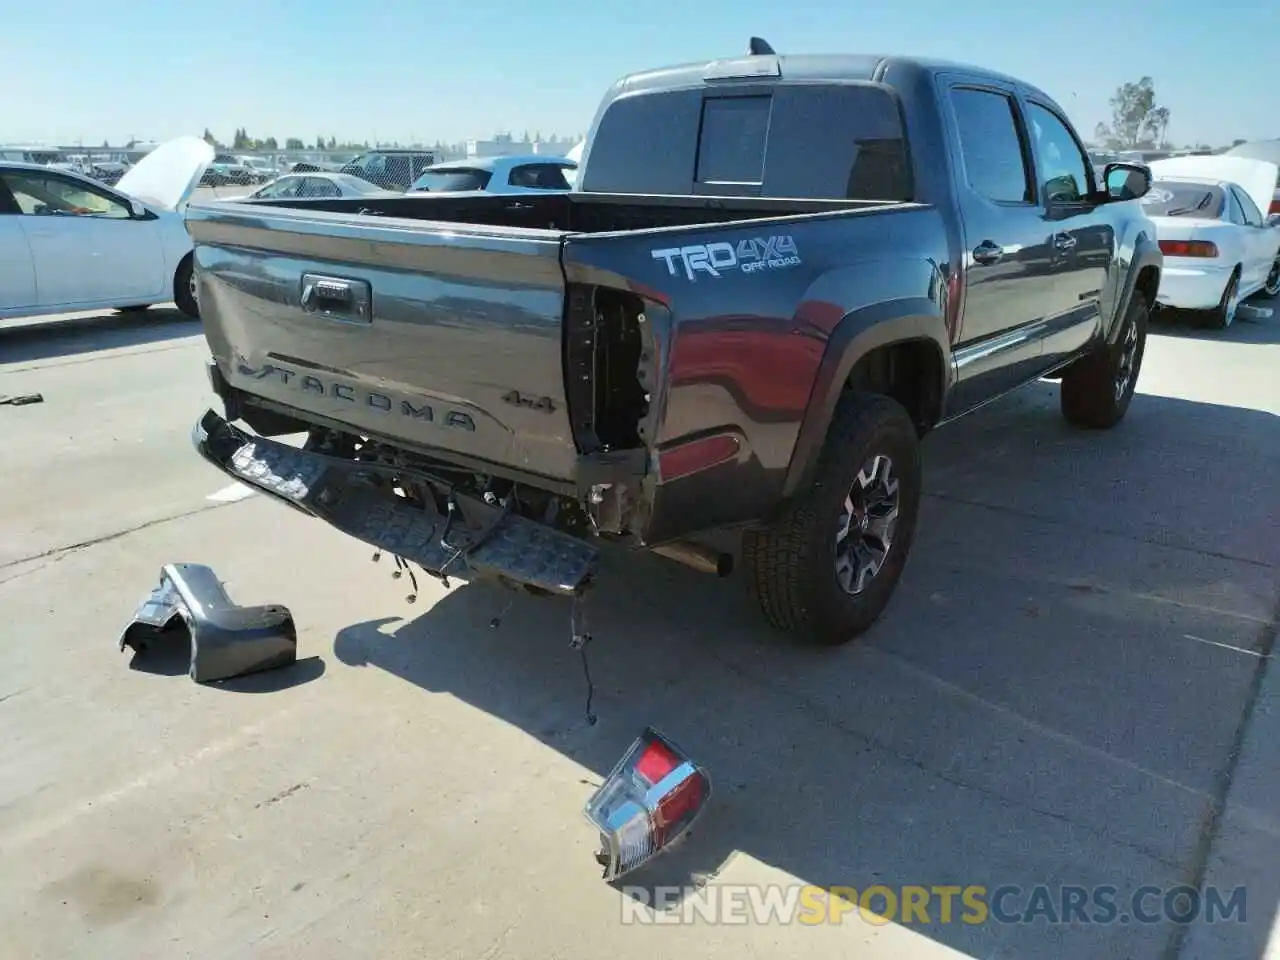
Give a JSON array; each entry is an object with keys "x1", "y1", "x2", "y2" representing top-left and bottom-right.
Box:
[{"x1": 836, "y1": 454, "x2": 901, "y2": 596}]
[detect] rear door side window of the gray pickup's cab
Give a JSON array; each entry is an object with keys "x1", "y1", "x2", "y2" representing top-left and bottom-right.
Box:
[{"x1": 951, "y1": 88, "x2": 1036, "y2": 204}]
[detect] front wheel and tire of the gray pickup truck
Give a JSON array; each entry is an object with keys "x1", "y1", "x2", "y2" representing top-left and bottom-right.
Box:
[{"x1": 1060, "y1": 291, "x2": 1151, "y2": 430}]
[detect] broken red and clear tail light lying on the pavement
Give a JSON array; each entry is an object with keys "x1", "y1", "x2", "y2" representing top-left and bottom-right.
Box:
[{"x1": 586, "y1": 727, "x2": 712, "y2": 881}]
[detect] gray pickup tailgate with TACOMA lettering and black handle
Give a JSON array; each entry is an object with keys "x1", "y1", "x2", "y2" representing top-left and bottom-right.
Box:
[{"x1": 187, "y1": 202, "x2": 577, "y2": 480}]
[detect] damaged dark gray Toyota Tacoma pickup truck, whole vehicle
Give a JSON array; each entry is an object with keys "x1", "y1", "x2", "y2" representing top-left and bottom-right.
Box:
[{"x1": 187, "y1": 41, "x2": 1162, "y2": 644}]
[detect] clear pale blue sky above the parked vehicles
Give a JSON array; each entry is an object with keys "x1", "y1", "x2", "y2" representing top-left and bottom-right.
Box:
[{"x1": 0, "y1": 0, "x2": 1280, "y2": 143}]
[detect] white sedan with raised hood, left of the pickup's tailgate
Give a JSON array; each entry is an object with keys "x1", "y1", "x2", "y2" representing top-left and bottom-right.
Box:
[{"x1": 0, "y1": 137, "x2": 214, "y2": 320}]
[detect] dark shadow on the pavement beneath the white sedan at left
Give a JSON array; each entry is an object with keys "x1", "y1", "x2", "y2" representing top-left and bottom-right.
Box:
[{"x1": 0, "y1": 306, "x2": 201, "y2": 364}]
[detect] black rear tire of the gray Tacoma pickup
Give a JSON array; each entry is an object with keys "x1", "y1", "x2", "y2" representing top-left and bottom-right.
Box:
[{"x1": 742, "y1": 393, "x2": 922, "y2": 645}]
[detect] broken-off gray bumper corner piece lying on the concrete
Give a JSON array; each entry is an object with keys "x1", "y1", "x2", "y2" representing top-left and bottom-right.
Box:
[{"x1": 119, "y1": 563, "x2": 298, "y2": 684}]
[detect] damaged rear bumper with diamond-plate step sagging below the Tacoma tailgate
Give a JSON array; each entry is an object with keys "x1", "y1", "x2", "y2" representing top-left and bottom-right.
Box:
[{"x1": 192, "y1": 410, "x2": 599, "y2": 596}]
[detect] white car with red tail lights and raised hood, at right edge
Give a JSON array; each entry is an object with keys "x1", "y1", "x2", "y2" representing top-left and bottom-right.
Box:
[{"x1": 1139, "y1": 156, "x2": 1280, "y2": 328}]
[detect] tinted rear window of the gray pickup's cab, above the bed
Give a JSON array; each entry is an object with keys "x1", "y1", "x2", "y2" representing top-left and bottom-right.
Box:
[{"x1": 581, "y1": 83, "x2": 914, "y2": 200}]
